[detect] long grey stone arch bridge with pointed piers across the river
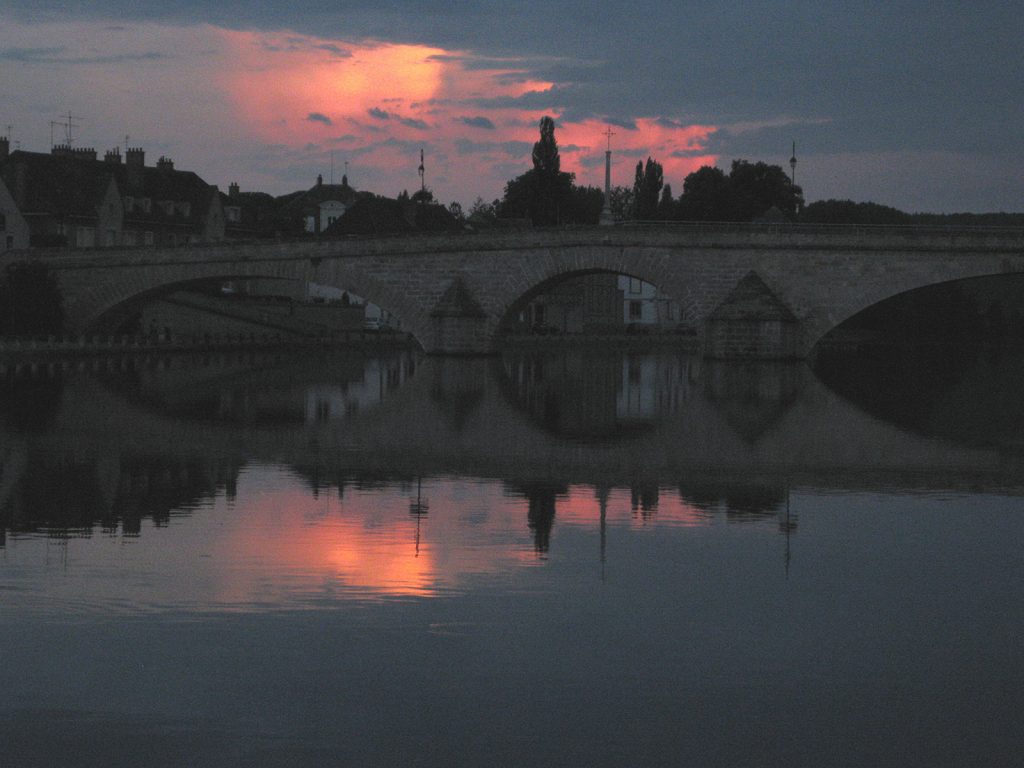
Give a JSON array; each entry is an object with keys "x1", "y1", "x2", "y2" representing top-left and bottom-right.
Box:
[{"x1": 5, "y1": 224, "x2": 1024, "y2": 357}]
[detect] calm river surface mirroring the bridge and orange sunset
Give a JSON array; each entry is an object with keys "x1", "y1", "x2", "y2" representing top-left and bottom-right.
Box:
[{"x1": 0, "y1": 352, "x2": 1024, "y2": 766}]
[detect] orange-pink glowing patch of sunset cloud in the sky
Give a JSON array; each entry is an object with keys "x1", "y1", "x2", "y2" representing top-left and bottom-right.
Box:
[{"x1": 216, "y1": 29, "x2": 717, "y2": 206}]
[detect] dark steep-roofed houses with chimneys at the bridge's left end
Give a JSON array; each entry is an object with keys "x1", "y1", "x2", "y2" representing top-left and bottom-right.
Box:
[{"x1": 0, "y1": 142, "x2": 225, "y2": 248}]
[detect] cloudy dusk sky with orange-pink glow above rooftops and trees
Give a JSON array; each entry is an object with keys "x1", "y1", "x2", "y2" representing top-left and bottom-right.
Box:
[{"x1": 0, "y1": 0, "x2": 1024, "y2": 213}]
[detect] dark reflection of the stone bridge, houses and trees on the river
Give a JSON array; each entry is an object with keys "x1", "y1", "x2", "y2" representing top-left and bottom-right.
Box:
[{"x1": 0, "y1": 351, "x2": 1024, "y2": 552}]
